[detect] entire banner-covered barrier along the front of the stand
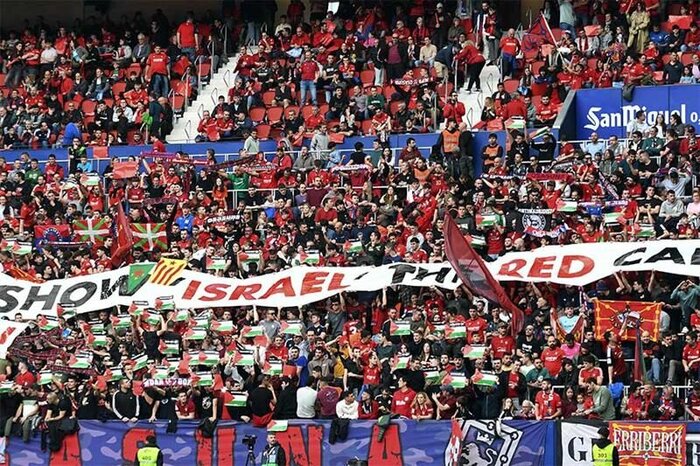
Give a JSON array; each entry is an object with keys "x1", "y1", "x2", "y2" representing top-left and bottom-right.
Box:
[{"x1": 8, "y1": 420, "x2": 700, "y2": 466}]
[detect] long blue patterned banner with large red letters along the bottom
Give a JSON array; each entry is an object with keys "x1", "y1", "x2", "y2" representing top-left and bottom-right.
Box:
[{"x1": 0, "y1": 420, "x2": 452, "y2": 466}]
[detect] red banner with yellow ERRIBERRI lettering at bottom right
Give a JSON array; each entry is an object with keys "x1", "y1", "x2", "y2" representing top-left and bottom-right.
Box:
[{"x1": 610, "y1": 422, "x2": 686, "y2": 466}]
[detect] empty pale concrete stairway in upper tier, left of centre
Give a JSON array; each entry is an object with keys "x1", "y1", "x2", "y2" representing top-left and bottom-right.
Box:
[{"x1": 166, "y1": 55, "x2": 238, "y2": 143}]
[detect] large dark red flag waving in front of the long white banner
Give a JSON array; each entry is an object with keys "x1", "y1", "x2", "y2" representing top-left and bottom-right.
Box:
[{"x1": 443, "y1": 214, "x2": 525, "y2": 335}]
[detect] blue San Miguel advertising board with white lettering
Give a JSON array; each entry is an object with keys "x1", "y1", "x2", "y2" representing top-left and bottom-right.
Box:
[{"x1": 575, "y1": 84, "x2": 700, "y2": 139}]
